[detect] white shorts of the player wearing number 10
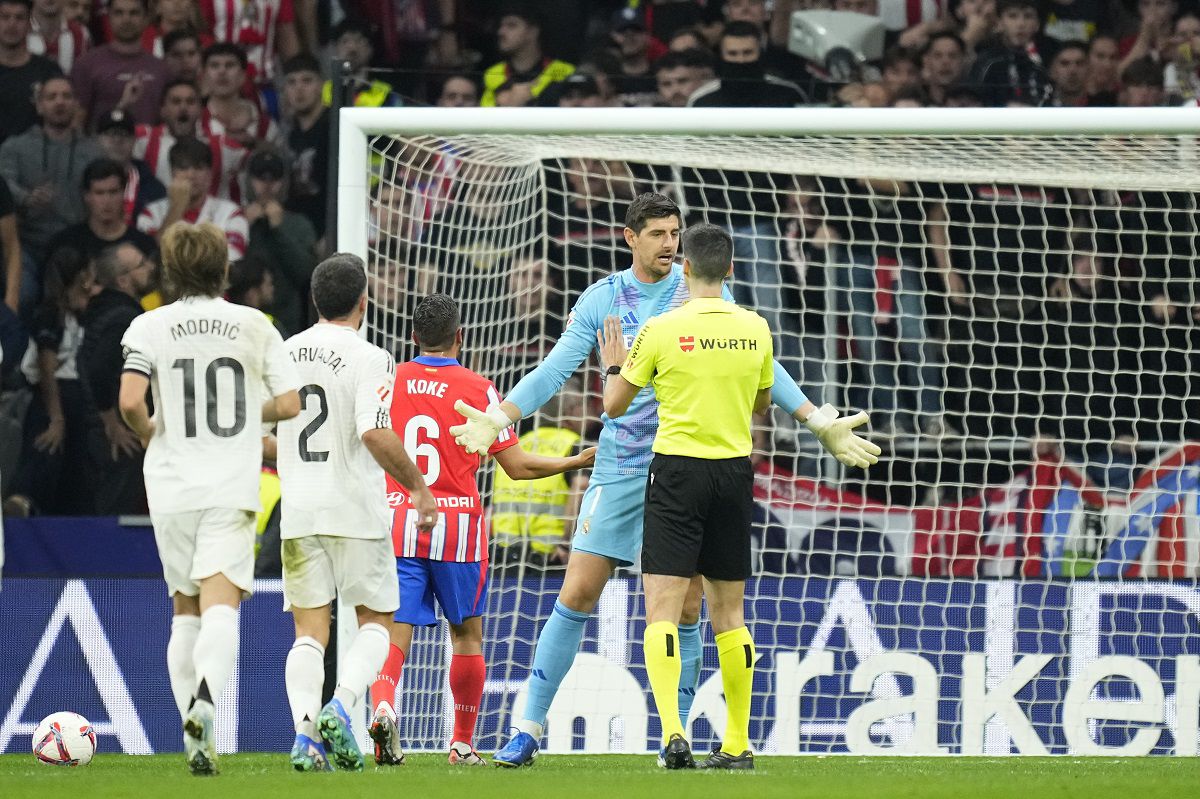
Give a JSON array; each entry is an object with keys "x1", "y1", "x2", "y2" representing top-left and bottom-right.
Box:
[{"x1": 150, "y1": 507, "x2": 256, "y2": 599}]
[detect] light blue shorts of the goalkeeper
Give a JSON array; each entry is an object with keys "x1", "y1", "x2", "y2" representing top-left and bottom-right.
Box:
[{"x1": 571, "y1": 475, "x2": 646, "y2": 566}]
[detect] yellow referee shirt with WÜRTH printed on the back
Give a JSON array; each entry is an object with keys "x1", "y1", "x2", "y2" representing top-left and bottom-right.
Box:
[{"x1": 620, "y1": 298, "x2": 774, "y2": 461}]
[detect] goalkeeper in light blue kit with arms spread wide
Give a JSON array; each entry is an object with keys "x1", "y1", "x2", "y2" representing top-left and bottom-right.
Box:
[{"x1": 450, "y1": 194, "x2": 880, "y2": 767}]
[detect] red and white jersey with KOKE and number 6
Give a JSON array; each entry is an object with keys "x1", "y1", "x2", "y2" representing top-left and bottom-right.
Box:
[{"x1": 388, "y1": 355, "x2": 517, "y2": 563}]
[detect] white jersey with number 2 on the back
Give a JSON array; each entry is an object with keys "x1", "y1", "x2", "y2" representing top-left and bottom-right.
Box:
[{"x1": 278, "y1": 323, "x2": 396, "y2": 539}]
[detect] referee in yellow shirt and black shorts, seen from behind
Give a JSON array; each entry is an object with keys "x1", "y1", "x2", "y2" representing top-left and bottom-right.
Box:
[{"x1": 604, "y1": 224, "x2": 774, "y2": 769}]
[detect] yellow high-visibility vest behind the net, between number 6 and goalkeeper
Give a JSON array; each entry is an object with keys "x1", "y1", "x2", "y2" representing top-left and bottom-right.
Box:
[{"x1": 492, "y1": 427, "x2": 580, "y2": 553}]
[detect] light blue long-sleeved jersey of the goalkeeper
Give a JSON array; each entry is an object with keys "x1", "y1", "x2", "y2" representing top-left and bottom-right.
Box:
[{"x1": 504, "y1": 264, "x2": 808, "y2": 482}]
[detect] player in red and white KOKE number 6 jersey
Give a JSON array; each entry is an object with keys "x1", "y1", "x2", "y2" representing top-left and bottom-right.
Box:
[{"x1": 371, "y1": 294, "x2": 595, "y2": 765}]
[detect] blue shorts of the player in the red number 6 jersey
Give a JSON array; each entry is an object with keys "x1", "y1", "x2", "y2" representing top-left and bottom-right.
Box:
[{"x1": 395, "y1": 558, "x2": 487, "y2": 627}]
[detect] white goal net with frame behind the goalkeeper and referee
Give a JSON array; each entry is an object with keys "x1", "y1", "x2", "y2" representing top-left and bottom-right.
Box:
[{"x1": 338, "y1": 109, "x2": 1200, "y2": 755}]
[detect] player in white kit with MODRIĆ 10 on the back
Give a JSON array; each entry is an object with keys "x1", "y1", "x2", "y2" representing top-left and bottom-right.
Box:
[{"x1": 119, "y1": 222, "x2": 300, "y2": 774}]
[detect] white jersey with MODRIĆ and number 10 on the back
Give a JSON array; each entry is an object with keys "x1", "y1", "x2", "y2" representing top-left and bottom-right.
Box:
[{"x1": 121, "y1": 298, "x2": 300, "y2": 513}]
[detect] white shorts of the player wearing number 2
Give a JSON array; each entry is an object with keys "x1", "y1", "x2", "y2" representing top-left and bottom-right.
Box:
[{"x1": 282, "y1": 535, "x2": 400, "y2": 613}]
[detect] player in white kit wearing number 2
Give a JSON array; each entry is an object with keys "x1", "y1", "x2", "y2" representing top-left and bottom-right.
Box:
[{"x1": 276, "y1": 253, "x2": 438, "y2": 771}]
